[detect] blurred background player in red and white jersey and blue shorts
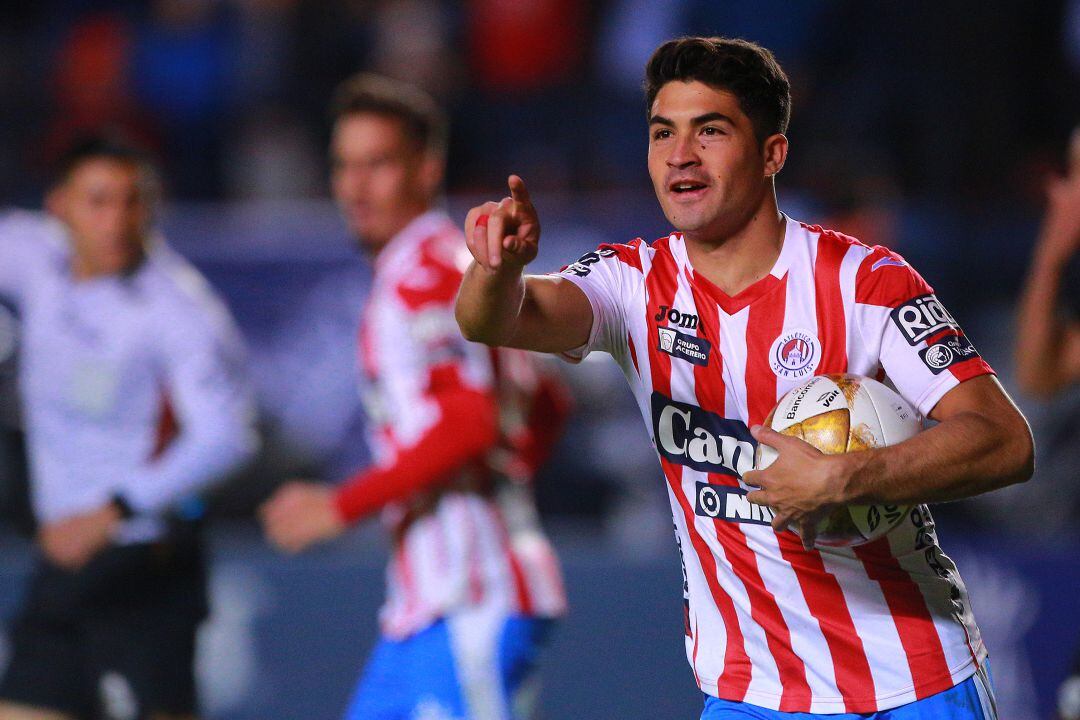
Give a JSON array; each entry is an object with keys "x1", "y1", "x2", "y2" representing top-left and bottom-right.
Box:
[{"x1": 264, "y1": 76, "x2": 566, "y2": 720}]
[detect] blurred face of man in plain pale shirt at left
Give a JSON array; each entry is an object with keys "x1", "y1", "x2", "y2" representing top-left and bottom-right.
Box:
[{"x1": 48, "y1": 158, "x2": 151, "y2": 276}]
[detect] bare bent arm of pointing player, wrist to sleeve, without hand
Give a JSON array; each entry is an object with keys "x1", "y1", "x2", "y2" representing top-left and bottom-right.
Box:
[{"x1": 455, "y1": 261, "x2": 593, "y2": 353}]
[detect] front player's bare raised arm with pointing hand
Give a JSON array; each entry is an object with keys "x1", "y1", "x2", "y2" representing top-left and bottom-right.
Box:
[{"x1": 455, "y1": 175, "x2": 593, "y2": 352}]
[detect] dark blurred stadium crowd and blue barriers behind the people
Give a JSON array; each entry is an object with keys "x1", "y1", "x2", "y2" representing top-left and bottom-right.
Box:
[{"x1": 0, "y1": 0, "x2": 1080, "y2": 720}]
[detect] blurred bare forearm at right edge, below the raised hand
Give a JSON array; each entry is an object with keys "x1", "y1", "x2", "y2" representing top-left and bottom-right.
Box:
[{"x1": 1015, "y1": 246, "x2": 1065, "y2": 395}]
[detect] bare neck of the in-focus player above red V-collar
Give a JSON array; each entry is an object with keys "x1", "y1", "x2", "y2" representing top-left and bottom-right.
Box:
[{"x1": 683, "y1": 190, "x2": 785, "y2": 297}]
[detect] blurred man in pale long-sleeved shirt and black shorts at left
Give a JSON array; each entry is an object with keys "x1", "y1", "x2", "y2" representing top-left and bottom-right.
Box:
[{"x1": 0, "y1": 138, "x2": 255, "y2": 720}]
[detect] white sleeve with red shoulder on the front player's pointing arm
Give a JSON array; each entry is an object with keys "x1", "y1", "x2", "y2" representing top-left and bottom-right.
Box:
[{"x1": 557, "y1": 239, "x2": 643, "y2": 362}]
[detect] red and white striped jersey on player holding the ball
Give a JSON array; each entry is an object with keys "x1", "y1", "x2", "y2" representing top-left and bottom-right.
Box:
[{"x1": 561, "y1": 219, "x2": 993, "y2": 714}]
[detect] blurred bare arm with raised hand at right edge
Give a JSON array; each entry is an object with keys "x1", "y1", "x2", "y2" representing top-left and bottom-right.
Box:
[{"x1": 1015, "y1": 127, "x2": 1080, "y2": 398}]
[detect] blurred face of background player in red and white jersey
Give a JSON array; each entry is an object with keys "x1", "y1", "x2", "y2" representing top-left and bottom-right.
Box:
[{"x1": 330, "y1": 113, "x2": 438, "y2": 252}]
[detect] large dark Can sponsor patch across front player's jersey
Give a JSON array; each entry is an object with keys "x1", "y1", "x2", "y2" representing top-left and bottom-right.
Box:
[{"x1": 652, "y1": 393, "x2": 756, "y2": 477}]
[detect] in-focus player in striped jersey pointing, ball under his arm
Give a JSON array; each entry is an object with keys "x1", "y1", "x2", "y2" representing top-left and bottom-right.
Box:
[{"x1": 457, "y1": 38, "x2": 1032, "y2": 720}]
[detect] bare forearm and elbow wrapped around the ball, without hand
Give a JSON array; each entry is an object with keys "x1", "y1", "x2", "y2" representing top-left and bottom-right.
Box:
[{"x1": 837, "y1": 376, "x2": 1035, "y2": 504}]
